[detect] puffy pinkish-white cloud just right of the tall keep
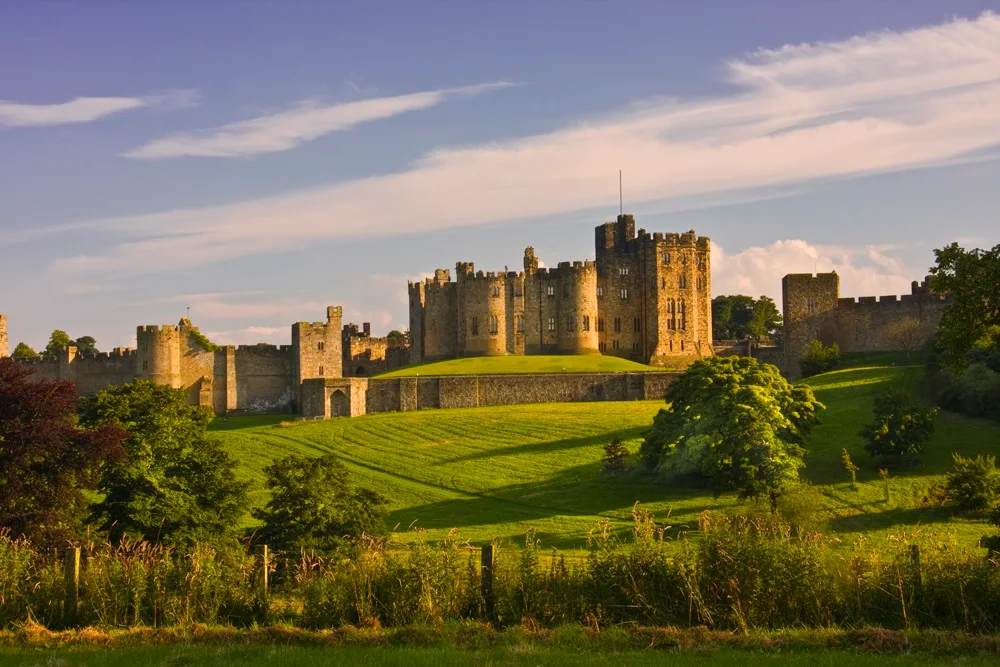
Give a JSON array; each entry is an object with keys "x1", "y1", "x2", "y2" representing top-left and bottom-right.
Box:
[{"x1": 712, "y1": 239, "x2": 926, "y2": 308}]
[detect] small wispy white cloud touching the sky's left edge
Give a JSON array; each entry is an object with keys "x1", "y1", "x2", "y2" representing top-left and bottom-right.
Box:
[{"x1": 0, "y1": 90, "x2": 197, "y2": 127}]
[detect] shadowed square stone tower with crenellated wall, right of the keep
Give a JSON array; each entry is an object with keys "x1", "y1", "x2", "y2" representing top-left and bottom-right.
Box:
[{"x1": 781, "y1": 272, "x2": 951, "y2": 377}]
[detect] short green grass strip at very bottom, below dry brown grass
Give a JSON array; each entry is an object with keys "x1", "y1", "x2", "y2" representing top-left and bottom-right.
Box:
[{"x1": 0, "y1": 644, "x2": 996, "y2": 667}]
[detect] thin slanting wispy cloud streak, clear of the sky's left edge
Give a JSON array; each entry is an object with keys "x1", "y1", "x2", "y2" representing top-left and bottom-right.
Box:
[{"x1": 124, "y1": 82, "x2": 513, "y2": 160}]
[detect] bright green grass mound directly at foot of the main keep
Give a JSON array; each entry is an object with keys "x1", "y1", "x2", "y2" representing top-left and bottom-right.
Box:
[{"x1": 378, "y1": 354, "x2": 669, "y2": 378}]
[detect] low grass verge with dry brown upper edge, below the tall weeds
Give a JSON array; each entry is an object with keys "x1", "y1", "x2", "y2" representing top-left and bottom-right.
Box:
[{"x1": 0, "y1": 623, "x2": 1000, "y2": 667}]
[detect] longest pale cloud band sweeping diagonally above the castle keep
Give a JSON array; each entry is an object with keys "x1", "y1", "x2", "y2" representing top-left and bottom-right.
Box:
[{"x1": 53, "y1": 13, "x2": 1000, "y2": 274}]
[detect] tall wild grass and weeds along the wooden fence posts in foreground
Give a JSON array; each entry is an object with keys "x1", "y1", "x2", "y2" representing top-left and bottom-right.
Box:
[{"x1": 0, "y1": 509, "x2": 1000, "y2": 633}]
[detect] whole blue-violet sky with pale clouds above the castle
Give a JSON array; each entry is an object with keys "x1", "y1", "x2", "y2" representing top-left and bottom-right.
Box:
[{"x1": 0, "y1": 0, "x2": 1000, "y2": 350}]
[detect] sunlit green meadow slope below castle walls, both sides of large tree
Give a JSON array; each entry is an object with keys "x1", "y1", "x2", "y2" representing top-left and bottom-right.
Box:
[{"x1": 212, "y1": 357, "x2": 1000, "y2": 548}]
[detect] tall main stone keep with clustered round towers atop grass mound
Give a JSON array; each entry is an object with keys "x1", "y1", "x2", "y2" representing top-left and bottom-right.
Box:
[{"x1": 409, "y1": 215, "x2": 712, "y2": 366}]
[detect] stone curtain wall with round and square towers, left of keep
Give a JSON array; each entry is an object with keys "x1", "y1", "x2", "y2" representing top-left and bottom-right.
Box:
[{"x1": 0, "y1": 306, "x2": 343, "y2": 415}]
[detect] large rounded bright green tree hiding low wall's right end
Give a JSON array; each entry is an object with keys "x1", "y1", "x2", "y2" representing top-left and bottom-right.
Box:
[{"x1": 640, "y1": 356, "x2": 823, "y2": 509}]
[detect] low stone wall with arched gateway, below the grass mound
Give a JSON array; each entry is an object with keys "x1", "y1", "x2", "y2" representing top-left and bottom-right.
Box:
[{"x1": 302, "y1": 371, "x2": 677, "y2": 418}]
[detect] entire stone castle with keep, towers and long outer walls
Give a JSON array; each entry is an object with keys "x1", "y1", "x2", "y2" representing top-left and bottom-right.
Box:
[{"x1": 0, "y1": 215, "x2": 951, "y2": 417}]
